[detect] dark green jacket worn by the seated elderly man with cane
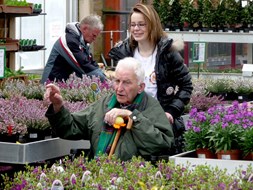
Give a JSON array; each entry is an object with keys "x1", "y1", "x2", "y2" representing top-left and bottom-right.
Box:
[{"x1": 46, "y1": 94, "x2": 174, "y2": 160}]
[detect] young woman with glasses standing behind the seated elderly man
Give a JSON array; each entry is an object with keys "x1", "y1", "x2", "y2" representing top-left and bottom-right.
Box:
[{"x1": 109, "y1": 3, "x2": 193, "y2": 154}]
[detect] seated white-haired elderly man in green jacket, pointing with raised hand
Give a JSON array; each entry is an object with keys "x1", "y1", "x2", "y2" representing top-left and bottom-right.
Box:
[{"x1": 44, "y1": 57, "x2": 174, "y2": 160}]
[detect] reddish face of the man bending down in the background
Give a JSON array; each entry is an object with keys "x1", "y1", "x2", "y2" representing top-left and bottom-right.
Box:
[{"x1": 80, "y1": 25, "x2": 101, "y2": 43}]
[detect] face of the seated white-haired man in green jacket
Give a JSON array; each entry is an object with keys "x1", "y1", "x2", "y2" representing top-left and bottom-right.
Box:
[{"x1": 114, "y1": 68, "x2": 145, "y2": 104}]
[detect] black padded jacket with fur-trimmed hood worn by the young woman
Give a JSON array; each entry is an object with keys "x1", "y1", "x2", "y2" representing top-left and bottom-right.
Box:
[{"x1": 109, "y1": 37, "x2": 193, "y2": 118}]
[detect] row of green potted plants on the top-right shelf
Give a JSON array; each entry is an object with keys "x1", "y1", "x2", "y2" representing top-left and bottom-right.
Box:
[{"x1": 154, "y1": 0, "x2": 253, "y2": 32}]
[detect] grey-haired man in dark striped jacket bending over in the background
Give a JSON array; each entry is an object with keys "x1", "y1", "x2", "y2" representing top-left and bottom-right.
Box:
[{"x1": 41, "y1": 15, "x2": 105, "y2": 83}]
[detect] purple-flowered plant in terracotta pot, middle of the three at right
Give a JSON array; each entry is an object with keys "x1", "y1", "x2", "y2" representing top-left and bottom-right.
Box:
[{"x1": 208, "y1": 101, "x2": 250, "y2": 160}]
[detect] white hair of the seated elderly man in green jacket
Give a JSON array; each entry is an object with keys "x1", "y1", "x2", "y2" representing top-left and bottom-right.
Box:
[{"x1": 115, "y1": 57, "x2": 145, "y2": 84}]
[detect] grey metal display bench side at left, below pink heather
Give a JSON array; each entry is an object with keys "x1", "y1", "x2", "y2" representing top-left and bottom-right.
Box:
[{"x1": 0, "y1": 138, "x2": 90, "y2": 164}]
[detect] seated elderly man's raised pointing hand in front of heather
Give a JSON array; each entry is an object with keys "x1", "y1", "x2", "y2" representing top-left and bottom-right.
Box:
[{"x1": 44, "y1": 84, "x2": 63, "y2": 113}]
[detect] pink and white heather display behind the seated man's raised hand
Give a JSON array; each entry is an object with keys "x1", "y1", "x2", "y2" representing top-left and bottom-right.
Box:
[{"x1": 0, "y1": 75, "x2": 111, "y2": 143}]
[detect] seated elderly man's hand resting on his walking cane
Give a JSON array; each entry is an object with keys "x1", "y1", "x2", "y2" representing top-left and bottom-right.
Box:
[{"x1": 104, "y1": 108, "x2": 132, "y2": 125}]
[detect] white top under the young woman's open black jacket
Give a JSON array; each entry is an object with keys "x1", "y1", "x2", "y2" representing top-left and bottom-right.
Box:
[{"x1": 134, "y1": 47, "x2": 157, "y2": 98}]
